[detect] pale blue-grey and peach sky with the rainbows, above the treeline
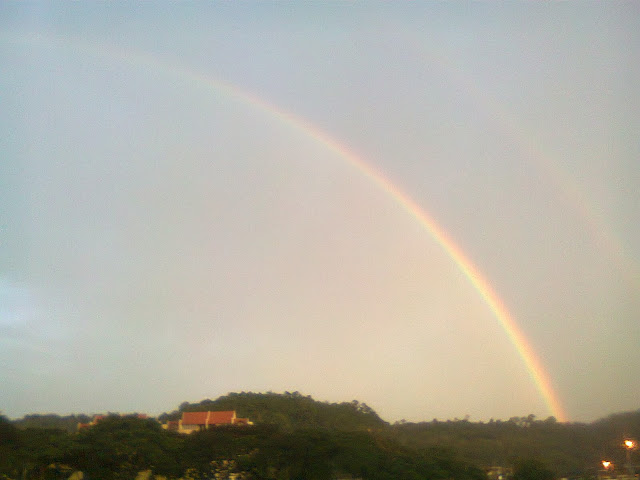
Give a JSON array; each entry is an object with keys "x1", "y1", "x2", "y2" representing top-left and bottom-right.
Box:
[{"x1": 0, "y1": 2, "x2": 640, "y2": 422}]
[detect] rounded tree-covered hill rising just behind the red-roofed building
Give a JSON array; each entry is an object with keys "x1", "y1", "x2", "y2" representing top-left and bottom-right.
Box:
[{"x1": 159, "y1": 392, "x2": 387, "y2": 430}]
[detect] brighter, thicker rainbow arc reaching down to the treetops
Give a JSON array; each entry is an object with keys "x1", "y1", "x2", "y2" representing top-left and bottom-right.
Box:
[{"x1": 10, "y1": 31, "x2": 567, "y2": 421}]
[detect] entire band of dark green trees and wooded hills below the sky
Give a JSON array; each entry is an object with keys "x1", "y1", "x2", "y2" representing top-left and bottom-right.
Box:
[{"x1": 0, "y1": 392, "x2": 640, "y2": 480}]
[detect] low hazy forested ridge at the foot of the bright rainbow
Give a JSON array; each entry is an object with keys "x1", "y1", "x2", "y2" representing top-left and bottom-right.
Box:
[{"x1": 389, "y1": 410, "x2": 640, "y2": 478}]
